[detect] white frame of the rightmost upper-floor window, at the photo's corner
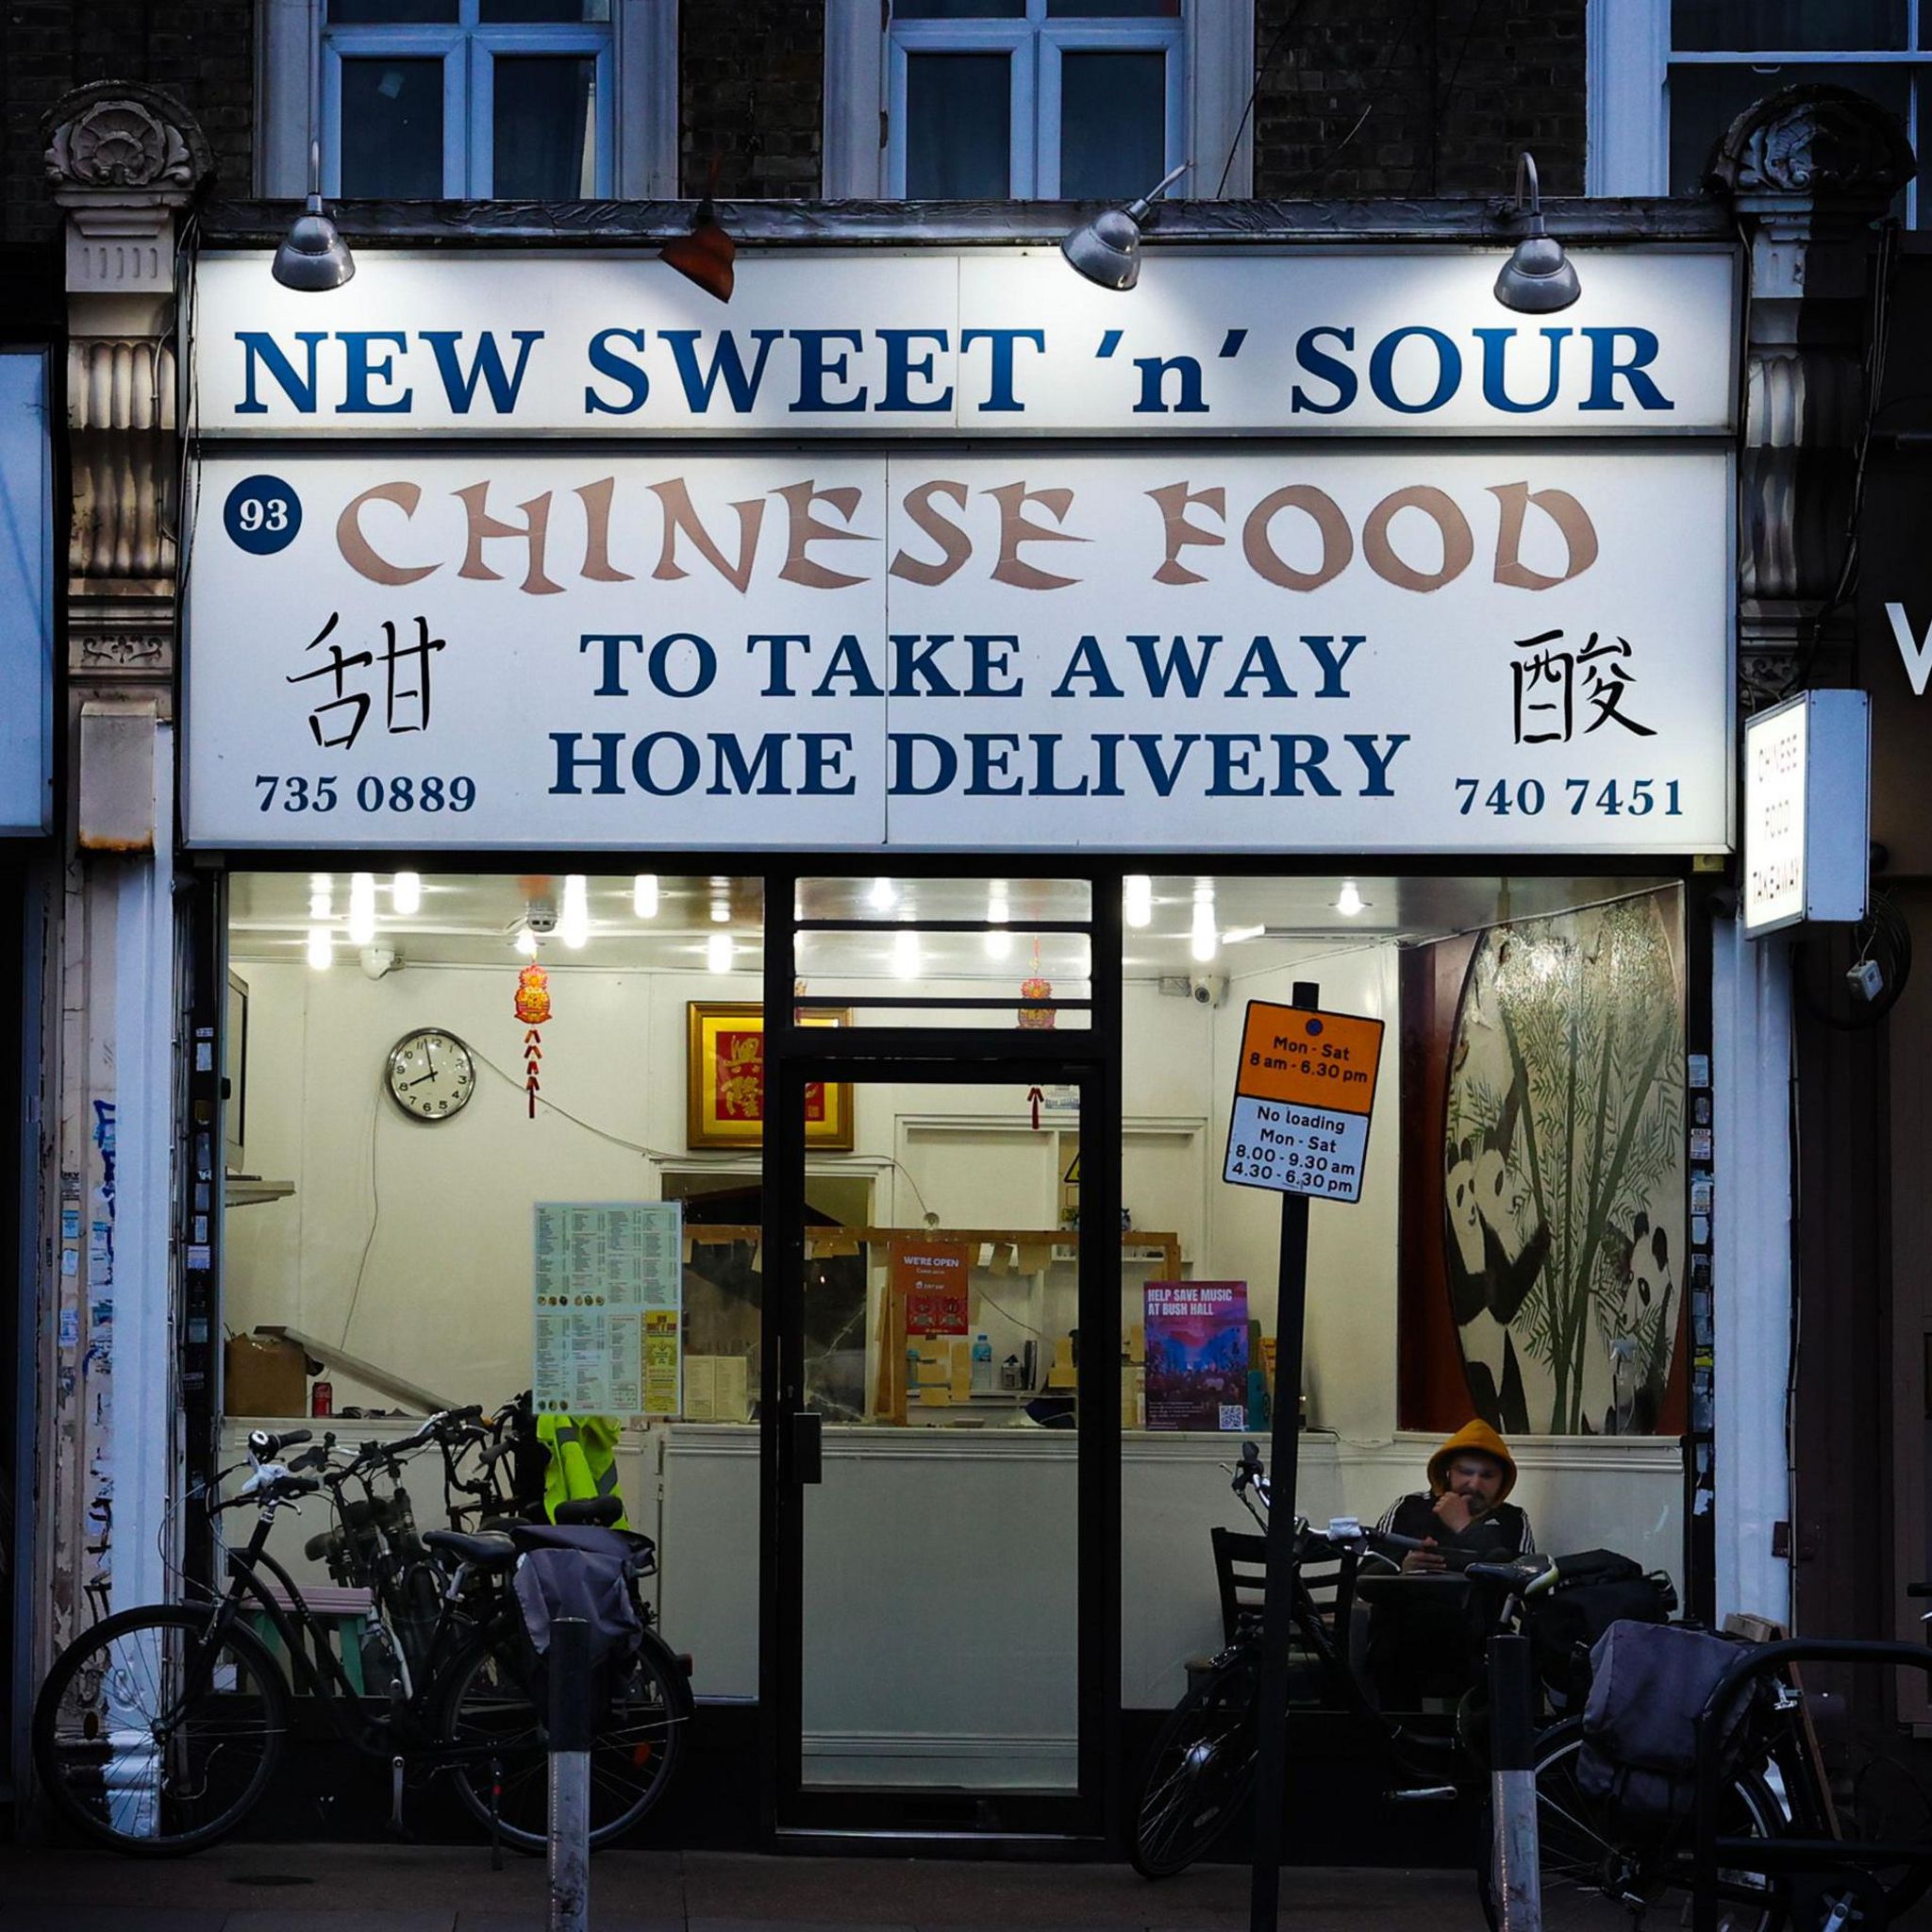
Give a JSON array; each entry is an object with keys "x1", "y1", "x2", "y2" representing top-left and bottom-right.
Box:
[{"x1": 1584, "y1": 0, "x2": 1932, "y2": 228}]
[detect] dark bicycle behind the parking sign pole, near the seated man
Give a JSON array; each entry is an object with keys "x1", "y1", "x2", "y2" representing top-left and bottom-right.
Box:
[{"x1": 1130, "y1": 1443, "x2": 1556, "y2": 1878}]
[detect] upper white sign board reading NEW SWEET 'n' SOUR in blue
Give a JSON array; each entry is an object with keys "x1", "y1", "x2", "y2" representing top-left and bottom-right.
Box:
[{"x1": 192, "y1": 243, "x2": 1737, "y2": 442}]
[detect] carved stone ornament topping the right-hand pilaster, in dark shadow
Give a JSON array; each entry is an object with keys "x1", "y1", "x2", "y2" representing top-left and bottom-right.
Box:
[{"x1": 1704, "y1": 85, "x2": 1919, "y2": 208}]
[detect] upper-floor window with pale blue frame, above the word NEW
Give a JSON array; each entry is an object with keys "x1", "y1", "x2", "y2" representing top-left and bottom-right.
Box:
[{"x1": 323, "y1": 0, "x2": 614, "y2": 201}]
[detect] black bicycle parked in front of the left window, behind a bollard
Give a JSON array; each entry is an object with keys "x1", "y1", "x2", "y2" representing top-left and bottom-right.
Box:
[{"x1": 31, "y1": 1410, "x2": 693, "y2": 1857}]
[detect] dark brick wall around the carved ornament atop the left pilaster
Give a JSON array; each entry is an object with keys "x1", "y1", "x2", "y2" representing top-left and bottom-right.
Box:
[{"x1": 0, "y1": 0, "x2": 255, "y2": 242}]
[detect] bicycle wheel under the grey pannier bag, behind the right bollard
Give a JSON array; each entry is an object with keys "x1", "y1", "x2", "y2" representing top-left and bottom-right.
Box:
[{"x1": 1476, "y1": 1718, "x2": 1785, "y2": 1932}]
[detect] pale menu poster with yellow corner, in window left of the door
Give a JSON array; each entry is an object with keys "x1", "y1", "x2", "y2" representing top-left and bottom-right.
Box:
[{"x1": 531, "y1": 1202, "x2": 684, "y2": 1416}]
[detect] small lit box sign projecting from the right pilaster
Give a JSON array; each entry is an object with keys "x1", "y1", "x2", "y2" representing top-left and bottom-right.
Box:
[{"x1": 1744, "y1": 691, "x2": 1873, "y2": 939}]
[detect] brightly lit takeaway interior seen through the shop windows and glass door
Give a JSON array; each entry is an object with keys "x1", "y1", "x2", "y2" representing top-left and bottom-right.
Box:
[{"x1": 223, "y1": 872, "x2": 1685, "y2": 1790}]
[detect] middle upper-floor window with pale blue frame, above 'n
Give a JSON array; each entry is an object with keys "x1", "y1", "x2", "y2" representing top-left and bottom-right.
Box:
[{"x1": 887, "y1": 0, "x2": 1196, "y2": 201}]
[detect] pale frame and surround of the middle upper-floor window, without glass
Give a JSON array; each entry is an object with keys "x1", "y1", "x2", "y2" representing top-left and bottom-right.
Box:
[{"x1": 821, "y1": 0, "x2": 1254, "y2": 201}]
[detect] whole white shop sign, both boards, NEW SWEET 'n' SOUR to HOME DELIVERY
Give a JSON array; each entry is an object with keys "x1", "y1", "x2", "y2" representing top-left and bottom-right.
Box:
[{"x1": 186, "y1": 255, "x2": 1731, "y2": 854}]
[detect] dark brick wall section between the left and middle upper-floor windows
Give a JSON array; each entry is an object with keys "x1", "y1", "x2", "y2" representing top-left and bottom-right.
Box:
[{"x1": 678, "y1": 0, "x2": 824, "y2": 201}]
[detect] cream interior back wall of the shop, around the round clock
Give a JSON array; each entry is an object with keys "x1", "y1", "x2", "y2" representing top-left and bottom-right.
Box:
[{"x1": 225, "y1": 949, "x2": 1397, "y2": 1440}]
